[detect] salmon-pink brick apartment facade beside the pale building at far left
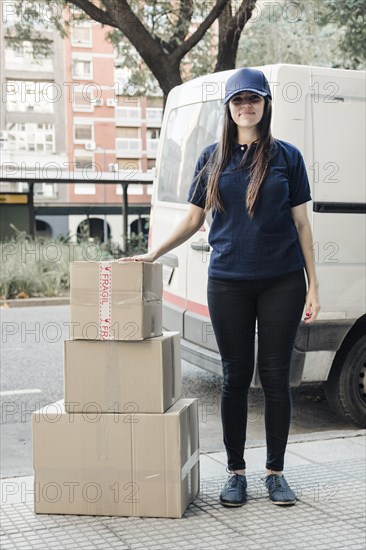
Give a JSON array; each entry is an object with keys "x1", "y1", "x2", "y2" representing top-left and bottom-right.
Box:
[{"x1": 64, "y1": 10, "x2": 121, "y2": 245}]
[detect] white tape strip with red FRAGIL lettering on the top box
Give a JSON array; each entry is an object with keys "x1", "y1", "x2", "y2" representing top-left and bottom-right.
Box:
[{"x1": 99, "y1": 262, "x2": 113, "y2": 340}]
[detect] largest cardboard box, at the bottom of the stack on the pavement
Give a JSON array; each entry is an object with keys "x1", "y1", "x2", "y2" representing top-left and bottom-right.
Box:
[{"x1": 32, "y1": 399, "x2": 199, "y2": 518}]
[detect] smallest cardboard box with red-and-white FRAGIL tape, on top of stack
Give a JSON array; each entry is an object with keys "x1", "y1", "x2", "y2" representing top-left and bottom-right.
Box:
[{"x1": 70, "y1": 261, "x2": 163, "y2": 340}]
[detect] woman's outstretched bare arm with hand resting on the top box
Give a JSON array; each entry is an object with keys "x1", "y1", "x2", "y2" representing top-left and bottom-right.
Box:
[{"x1": 120, "y1": 204, "x2": 206, "y2": 262}]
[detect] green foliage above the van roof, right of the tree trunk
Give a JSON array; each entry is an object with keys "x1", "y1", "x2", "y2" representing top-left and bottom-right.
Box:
[{"x1": 236, "y1": 0, "x2": 365, "y2": 69}]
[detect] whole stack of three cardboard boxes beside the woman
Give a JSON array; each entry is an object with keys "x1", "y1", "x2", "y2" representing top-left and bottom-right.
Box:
[{"x1": 32, "y1": 262, "x2": 199, "y2": 518}]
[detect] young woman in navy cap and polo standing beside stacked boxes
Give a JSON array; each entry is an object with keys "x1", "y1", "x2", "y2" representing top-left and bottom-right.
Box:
[{"x1": 122, "y1": 68, "x2": 320, "y2": 507}]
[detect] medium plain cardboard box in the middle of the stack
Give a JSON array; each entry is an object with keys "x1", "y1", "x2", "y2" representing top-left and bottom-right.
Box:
[{"x1": 64, "y1": 332, "x2": 181, "y2": 413}]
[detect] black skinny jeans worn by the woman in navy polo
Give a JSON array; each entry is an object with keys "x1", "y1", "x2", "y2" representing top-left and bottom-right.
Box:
[{"x1": 207, "y1": 268, "x2": 306, "y2": 471}]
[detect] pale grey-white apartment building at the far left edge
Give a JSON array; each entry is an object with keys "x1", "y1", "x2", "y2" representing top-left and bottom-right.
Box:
[{"x1": 0, "y1": 4, "x2": 68, "y2": 235}]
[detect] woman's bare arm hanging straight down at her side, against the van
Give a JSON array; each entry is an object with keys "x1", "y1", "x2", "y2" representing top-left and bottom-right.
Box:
[{"x1": 291, "y1": 203, "x2": 320, "y2": 323}]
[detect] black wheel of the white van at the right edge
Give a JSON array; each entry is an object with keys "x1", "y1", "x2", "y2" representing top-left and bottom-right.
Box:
[{"x1": 324, "y1": 336, "x2": 366, "y2": 428}]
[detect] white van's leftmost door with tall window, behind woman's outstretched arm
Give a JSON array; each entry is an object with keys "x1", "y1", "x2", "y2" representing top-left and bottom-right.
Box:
[{"x1": 149, "y1": 103, "x2": 201, "y2": 337}]
